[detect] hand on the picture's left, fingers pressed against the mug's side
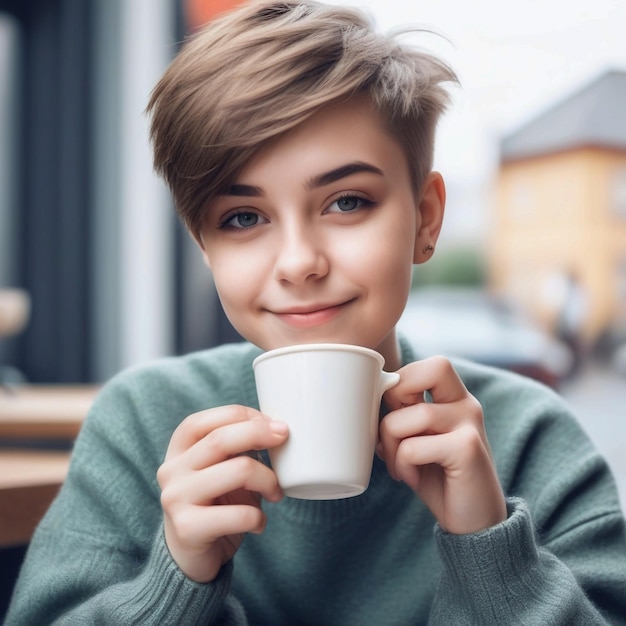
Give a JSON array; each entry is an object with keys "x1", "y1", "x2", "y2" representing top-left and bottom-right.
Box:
[{"x1": 157, "y1": 406, "x2": 288, "y2": 582}]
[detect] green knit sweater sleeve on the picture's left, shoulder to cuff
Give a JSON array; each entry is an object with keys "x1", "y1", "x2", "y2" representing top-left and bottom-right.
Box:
[{"x1": 6, "y1": 360, "x2": 251, "y2": 626}]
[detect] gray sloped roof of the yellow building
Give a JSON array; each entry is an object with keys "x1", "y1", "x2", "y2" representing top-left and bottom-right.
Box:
[{"x1": 500, "y1": 70, "x2": 626, "y2": 161}]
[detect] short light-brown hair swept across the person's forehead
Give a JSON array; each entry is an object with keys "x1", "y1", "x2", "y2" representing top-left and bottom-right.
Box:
[{"x1": 146, "y1": 0, "x2": 457, "y2": 237}]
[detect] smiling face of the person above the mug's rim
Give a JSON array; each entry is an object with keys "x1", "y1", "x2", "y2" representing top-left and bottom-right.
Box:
[{"x1": 199, "y1": 98, "x2": 443, "y2": 367}]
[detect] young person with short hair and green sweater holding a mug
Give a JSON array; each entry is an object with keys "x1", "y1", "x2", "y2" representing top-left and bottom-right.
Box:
[{"x1": 7, "y1": 0, "x2": 626, "y2": 626}]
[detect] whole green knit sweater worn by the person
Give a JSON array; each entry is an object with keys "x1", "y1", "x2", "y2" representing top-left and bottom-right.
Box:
[{"x1": 6, "y1": 344, "x2": 626, "y2": 626}]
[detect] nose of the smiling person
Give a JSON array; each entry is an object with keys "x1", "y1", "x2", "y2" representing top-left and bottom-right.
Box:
[{"x1": 274, "y1": 224, "x2": 330, "y2": 284}]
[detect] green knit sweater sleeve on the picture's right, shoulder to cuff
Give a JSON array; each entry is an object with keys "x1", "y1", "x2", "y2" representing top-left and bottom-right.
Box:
[{"x1": 431, "y1": 360, "x2": 626, "y2": 626}]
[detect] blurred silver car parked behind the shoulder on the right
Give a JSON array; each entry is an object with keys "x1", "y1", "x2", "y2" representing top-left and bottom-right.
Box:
[{"x1": 398, "y1": 287, "x2": 573, "y2": 389}]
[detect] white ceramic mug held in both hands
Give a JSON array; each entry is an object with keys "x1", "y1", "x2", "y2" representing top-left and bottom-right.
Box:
[{"x1": 253, "y1": 343, "x2": 400, "y2": 500}]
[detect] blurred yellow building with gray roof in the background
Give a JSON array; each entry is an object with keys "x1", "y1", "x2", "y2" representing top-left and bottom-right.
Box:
[{"x1": 489, "y1": 71, "x2": 626, "y2": 342}]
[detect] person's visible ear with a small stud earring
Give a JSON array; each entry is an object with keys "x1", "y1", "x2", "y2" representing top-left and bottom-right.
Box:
[{"x1": 413, "y1": 172, "x2": 446, "y2": 264}]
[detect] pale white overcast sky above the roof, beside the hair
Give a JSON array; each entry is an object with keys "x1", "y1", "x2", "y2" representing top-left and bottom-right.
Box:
[{"x1": 334, "y1": 0, "x2": 626, "y2": 180}]
